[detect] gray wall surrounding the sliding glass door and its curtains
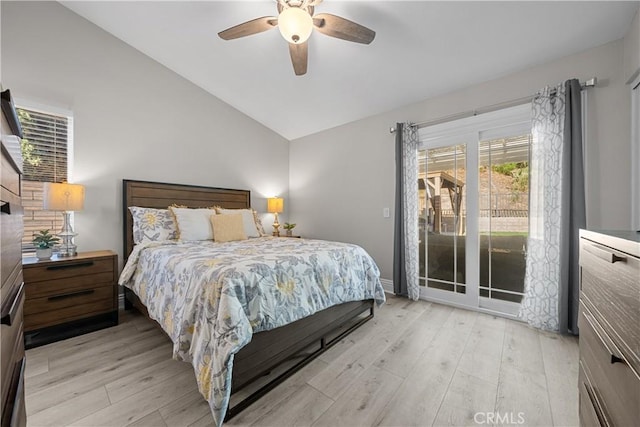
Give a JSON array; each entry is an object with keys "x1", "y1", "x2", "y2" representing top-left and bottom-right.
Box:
[{"x1": 289, "y1": 40, "x2": 631, "y2": 279}]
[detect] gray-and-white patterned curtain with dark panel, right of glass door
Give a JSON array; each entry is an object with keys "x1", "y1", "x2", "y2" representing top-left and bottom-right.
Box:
[{"x1": 519, "y1": 79, "x2": 586, "y2": 334}]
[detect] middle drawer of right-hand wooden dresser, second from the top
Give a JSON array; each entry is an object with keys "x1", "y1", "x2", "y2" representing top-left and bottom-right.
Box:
[{"x1": 579, "y1": 307, "x2": 640, "y2": 426}]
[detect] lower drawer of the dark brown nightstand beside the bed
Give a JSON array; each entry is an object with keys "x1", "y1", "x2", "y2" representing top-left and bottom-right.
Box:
[{"x1": 24, "y1": 284, "x2": 116, "y2": 316}]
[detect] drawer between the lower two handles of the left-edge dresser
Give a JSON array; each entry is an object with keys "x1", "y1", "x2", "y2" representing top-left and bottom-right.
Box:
[{"x1": 0, "y1": 284, "x2": 24, "y2": 412}]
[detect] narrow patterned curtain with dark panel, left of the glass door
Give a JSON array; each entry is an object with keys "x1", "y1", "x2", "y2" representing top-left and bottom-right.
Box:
[{"x1": 393, "y1": 123, "x2": 420, "y2": 300}]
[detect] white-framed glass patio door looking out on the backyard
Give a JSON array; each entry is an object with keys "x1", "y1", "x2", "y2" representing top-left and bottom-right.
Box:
[{"x1": 418, "y1": 107, "x2": 531, "y2": 315}]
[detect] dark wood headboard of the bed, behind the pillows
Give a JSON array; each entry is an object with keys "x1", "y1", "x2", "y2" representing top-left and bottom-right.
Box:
[{"x1": 122, "y1": 179, "x2": 251, "y2": 261}]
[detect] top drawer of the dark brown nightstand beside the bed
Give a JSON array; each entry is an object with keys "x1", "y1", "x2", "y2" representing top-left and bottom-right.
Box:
[{"x1": 24, "y1": 258, "x2": 114, "y2": 284}]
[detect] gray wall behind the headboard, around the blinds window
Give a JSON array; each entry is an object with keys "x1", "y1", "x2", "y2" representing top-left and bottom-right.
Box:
[{"x1": 2, "y1": 1, "x2": 289, "y2": 259}]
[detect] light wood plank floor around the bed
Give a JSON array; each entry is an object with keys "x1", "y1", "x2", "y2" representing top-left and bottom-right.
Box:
[{"x1": 26, "y1": 296, "x2": 578, "y2": 427}]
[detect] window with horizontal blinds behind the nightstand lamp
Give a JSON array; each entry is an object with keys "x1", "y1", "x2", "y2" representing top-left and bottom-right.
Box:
[{"x1": 17, "y1": 107, "x2": 72, "y2": 253}]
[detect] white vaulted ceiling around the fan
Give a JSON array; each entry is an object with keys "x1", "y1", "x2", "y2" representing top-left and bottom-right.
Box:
[{"x1": 61, "y1": 0, "x2": 640, "y2": 140}]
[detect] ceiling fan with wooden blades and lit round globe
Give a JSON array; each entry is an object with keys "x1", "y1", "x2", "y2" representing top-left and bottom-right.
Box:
[{"x1": 218, "y1": 0, "x2": 376, "y2": 76}]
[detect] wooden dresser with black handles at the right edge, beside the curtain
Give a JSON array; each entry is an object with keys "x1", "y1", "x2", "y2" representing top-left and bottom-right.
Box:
[{"x1": 578, "y1": 230, "x2": 640, "y2": 426}]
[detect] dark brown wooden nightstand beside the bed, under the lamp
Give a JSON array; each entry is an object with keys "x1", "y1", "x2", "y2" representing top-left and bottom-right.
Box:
[{"x1": 22, "y1": 251, "x2": 118, "y2": 348}]
